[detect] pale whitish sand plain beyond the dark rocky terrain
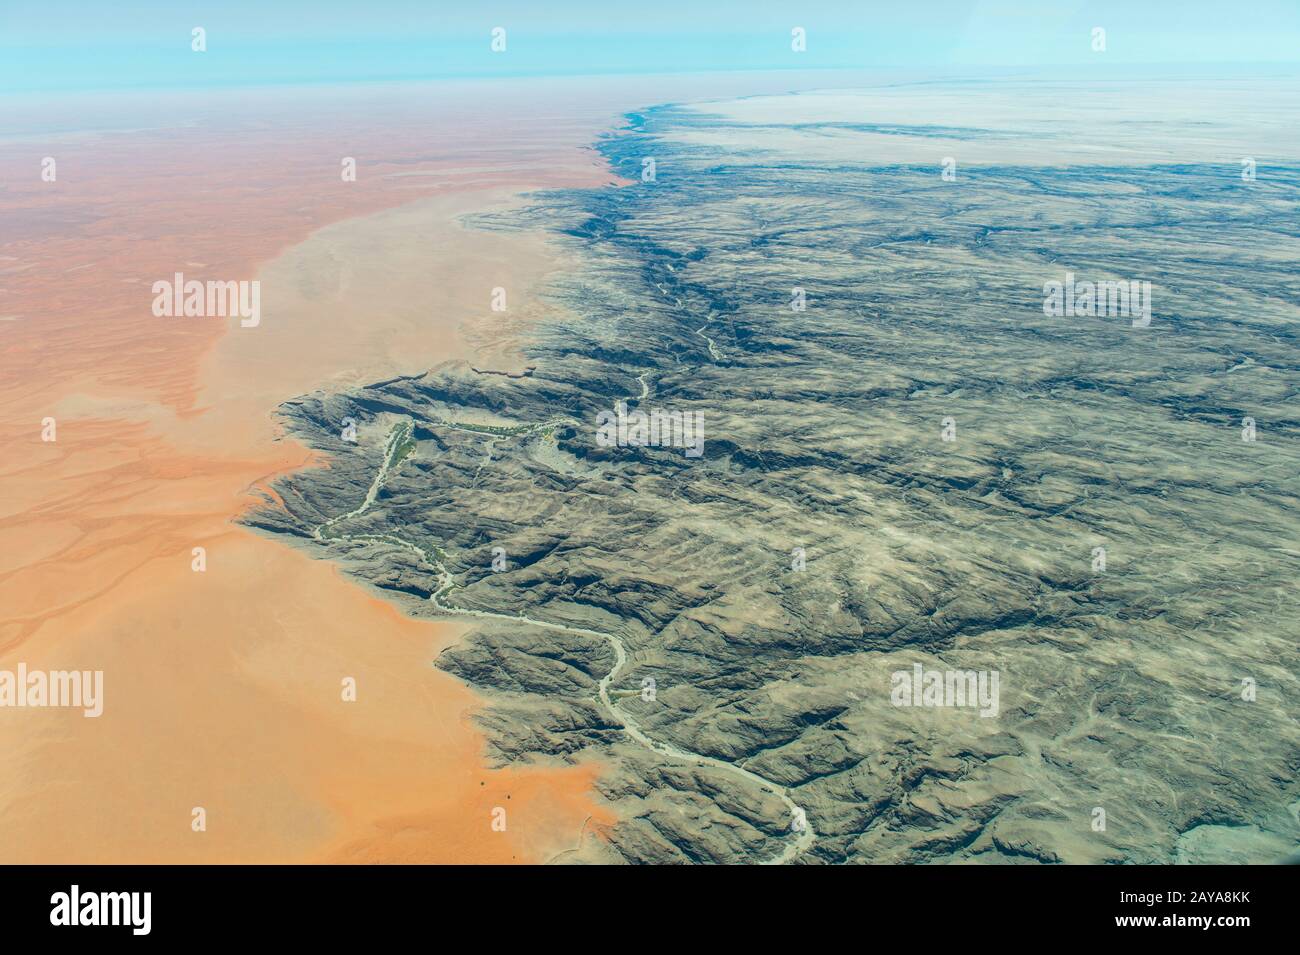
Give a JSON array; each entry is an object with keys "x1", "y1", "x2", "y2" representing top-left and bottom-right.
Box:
[{"x1": 679, "y1": 74, "x2": 1300, "y2": 167}]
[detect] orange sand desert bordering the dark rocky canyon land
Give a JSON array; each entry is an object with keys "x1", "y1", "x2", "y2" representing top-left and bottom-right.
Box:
[{"x1": 0, "y1": 78, "x2": 637, "y2": 863}]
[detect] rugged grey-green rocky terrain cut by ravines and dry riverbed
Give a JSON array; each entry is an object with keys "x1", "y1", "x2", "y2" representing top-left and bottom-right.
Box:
[{"x1": 250, "y1": 98, "x2": 1300, "y2": 863}]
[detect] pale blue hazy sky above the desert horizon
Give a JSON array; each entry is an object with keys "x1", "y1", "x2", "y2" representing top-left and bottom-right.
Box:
[{"x1": 0, "y1": 0, "x2": 1300, "y2": 91}]
